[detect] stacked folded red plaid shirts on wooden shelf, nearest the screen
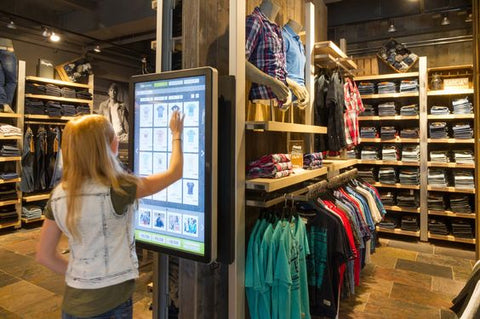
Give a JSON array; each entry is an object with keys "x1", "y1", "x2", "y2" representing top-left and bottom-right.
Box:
[{"x1": 247, "y1": 154, "x2": 293, "y2": 178}]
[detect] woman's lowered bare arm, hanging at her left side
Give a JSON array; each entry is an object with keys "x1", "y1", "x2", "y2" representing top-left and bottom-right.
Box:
[{"x1": 35, "y1": 219, "x2": 68, "y2": 275}]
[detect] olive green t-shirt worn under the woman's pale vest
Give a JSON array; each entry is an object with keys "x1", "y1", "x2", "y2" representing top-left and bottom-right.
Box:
[{"x1": 44, "y1": 183, "x2": 137, "y2": 317}]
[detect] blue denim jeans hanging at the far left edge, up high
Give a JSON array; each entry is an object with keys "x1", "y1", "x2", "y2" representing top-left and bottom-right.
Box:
[{"x1": 0, "y1": 50, "x2": 17, "y2": 106}]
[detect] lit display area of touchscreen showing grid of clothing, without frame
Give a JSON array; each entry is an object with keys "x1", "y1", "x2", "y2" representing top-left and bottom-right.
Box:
[{"x1": 132, "y1": 75, "x2": 208, "y2": 256}]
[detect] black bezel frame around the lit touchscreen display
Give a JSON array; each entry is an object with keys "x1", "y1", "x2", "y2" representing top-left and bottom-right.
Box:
[{"x1": 128, "y1": 67, "x2": 218, "y2": 263}]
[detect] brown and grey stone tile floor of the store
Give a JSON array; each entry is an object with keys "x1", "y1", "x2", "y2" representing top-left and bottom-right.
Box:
[{"x1": 0, "y1": 228, "x2": 475, "y2": 319}]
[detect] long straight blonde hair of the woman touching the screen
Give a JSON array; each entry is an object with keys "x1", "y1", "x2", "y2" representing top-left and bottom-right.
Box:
[{"x1": 61, "y1": 114, "x2": 138, "y2": 239}]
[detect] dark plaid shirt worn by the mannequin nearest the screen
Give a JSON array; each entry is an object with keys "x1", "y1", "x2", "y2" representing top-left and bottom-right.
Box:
[{"x1": 245, "y1": 7, "x2": 287, "y2": 100}]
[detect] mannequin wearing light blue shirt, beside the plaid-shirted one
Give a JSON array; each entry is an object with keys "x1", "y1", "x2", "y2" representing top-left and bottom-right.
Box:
[{"x1": 282, "y1": 19, "x2": 310, "y2": 109}]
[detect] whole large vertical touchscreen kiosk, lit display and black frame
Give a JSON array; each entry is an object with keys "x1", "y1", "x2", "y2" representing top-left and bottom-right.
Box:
[{"x1": 130, "y1": 67, "x2": 218, "y2": 262}]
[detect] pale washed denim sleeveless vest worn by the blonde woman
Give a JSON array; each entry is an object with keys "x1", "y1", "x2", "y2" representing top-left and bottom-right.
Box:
[{"x1": 51, "y1": 183, "x2": 138, "y2": 289}]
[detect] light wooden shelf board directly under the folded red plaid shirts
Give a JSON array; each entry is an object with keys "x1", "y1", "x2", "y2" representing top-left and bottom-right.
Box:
[{"x1": 245, "y1": 167, "x2": 328, "y2": 192}]
